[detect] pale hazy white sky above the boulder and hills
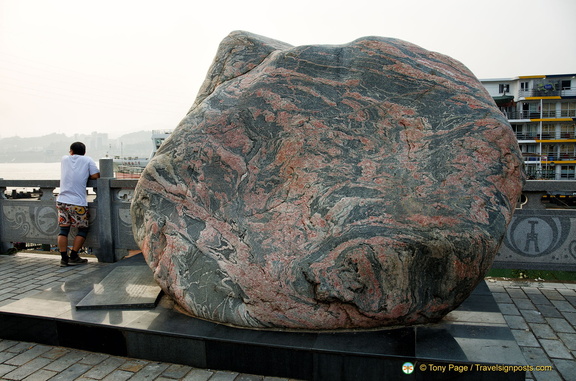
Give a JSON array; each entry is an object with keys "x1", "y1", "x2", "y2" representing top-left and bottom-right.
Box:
[{"x1": 0, "y1": 0, "x2": 576, "y2": 138}]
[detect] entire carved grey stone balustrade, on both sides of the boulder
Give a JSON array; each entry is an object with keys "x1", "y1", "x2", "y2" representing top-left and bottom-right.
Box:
[{"x1": 0, "y1": 159, "x2": 576, "y2": 271}]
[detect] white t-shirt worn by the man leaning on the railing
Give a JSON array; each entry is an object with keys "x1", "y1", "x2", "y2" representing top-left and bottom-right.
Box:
[{"x1": 57, "y1": 155, "x2": 100, "y2": 206}]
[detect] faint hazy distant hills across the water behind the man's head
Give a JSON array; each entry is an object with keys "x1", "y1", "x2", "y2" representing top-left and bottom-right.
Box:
[{"x1": 0, "y1": 131, "x2": 152, "y2": 163}]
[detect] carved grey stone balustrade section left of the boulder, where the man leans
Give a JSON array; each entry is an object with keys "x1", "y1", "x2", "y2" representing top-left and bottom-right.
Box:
[{"x1": 0, "y1": 159, "x2": 138, "y2": 262}]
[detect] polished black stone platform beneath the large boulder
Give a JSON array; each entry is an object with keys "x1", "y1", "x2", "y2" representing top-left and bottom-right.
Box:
[{"x1": 0, "y1": 256, "x2": 527, "y2": 381}]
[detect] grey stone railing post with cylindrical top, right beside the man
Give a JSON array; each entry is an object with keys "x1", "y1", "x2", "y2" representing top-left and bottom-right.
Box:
[{"x1": 96, "y1": 159, "x2": 117, "y2": 262}]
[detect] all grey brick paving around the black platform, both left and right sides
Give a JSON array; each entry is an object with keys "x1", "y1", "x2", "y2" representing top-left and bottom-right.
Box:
[{"x1": 0, "y1": 252, "x2": 576, "y2": 381}]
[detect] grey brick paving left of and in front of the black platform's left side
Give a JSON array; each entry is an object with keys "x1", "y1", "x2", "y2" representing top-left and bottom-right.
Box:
[{"x1": 0, "y1": 252, "x2": 288, "y2": 381}]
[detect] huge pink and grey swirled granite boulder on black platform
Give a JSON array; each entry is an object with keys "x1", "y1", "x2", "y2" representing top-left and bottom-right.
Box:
[{"x1": 132, "y1": 32, "x2": 524, "y2": 330}]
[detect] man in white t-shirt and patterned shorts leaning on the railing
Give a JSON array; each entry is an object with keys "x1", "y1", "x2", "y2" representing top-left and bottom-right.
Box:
[{"x1": 56, "y1": 142, "x2": 100, "y2": 267}]
